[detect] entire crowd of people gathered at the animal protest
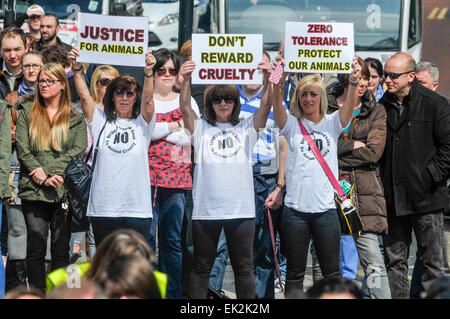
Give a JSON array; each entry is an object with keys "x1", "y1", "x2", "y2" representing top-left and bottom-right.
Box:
[{"x1": 0, "y1": 5, "x2": 450, "y2": 299}]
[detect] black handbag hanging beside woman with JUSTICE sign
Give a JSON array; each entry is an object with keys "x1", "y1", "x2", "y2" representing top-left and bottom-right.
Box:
[{"x1": 63, "y1": 122, "x2": 106, "y2": 223}]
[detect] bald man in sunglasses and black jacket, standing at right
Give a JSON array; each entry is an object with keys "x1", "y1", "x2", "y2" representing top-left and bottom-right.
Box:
[{"x1": 380, "y1": 53, "x2": 450, "y2": 299}]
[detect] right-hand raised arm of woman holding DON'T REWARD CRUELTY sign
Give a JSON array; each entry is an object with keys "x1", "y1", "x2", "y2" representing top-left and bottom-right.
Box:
[{"x1": 253, "y1": 62, "x2": 273, "y2": 131}]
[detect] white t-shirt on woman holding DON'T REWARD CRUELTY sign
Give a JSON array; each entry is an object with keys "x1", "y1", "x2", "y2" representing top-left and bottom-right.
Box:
[{"x1": 192, "y1": 116, "x2": 258, "y2": 220}]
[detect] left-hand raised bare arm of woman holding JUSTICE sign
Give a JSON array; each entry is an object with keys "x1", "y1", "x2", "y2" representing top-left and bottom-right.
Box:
[{"x1": 68, "y1": 47, "x2": 95, "y2": 123}]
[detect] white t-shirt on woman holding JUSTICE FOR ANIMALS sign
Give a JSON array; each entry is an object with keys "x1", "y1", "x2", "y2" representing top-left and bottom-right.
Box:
[{"x1": 87, "y1": 106, "x2": 156, "y2": 218}]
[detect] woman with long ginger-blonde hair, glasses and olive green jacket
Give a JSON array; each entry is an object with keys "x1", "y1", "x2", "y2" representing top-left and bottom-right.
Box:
[{"x1": 16, "y1": 63, "x2": 87, "y2": 290}]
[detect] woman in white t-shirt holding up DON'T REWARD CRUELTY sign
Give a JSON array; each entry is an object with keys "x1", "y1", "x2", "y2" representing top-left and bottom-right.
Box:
[{"x1": 180, "y1": 61, "x2": 272, "y2": 299}]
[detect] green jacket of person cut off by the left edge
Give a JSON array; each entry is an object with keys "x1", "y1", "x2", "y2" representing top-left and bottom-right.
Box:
[{"x1": 0, "y1": 100, "x2": 11, "y2": 199}]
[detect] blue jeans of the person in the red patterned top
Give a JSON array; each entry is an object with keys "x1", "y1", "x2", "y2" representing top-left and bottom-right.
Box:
[{"x1": 148, "y1": 187, "x2": 186, "y2": 299}]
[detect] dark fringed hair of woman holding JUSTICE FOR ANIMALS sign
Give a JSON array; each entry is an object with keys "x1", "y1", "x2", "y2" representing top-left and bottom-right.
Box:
[{"x1": 103, "y1": 75, "x2": 142, "y2": 122}]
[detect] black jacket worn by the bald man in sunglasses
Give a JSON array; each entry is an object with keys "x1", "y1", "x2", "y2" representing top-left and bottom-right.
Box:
[{"x1": 379, "y1": 79, "x2": 450, "y2": 216}]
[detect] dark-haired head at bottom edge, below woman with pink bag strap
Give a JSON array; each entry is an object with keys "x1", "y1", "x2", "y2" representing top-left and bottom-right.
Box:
[{"x1": 306, "y1": 277, "x2": 363, "y2": 299}]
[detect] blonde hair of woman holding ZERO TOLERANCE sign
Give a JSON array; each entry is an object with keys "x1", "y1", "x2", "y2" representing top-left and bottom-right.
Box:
[{"x1": 289, "y1": 75, "x2": 328, "y2": 122}]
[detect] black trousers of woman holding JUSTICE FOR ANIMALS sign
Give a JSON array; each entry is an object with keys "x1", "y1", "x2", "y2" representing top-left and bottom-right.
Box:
[{"x1": 90, "y1": 217, "x2": 152, "y2": 247}]
